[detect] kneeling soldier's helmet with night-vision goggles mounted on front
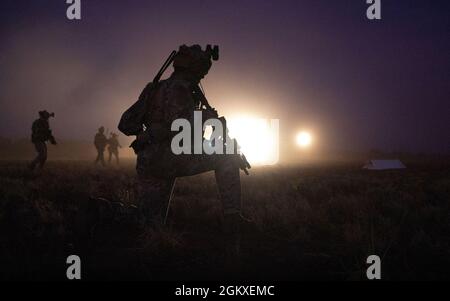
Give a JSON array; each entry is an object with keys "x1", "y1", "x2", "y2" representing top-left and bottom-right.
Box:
[{"x1": 173, "y1": 45, "x2": 218, "y2": 78}]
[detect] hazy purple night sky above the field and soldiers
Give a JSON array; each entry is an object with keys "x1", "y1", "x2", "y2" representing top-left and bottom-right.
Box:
[{"x1": 0, "y1": 0, "x2": 450, "y2": 152}]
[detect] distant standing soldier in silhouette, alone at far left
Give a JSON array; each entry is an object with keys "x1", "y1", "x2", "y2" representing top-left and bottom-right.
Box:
[{"x1": 29, "y1": 111, "x2": 56, "y2": 170}]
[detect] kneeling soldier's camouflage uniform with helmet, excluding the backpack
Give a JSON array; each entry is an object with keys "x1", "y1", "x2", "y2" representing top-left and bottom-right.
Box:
[{"x1": 125, "y1": 46, "x2": 241, "y2": 224}]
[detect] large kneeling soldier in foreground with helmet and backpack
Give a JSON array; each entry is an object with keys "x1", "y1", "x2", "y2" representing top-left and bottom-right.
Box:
[{"x1": 119, "y1": 45, "x2": 250, "y2": 251}]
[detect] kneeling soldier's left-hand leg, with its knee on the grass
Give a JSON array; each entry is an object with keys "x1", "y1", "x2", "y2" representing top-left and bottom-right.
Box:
[{"x1": 137, "y1": 175, "x2": 174, "y2": 227}]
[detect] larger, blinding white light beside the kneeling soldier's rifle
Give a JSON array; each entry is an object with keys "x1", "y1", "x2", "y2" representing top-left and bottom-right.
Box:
[{"x1": 222, "y1": 116, "x2": 279, "y2": 165}]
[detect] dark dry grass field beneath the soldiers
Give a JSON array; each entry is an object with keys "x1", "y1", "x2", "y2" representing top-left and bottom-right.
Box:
[{"x1": 0, "y1": 161, "x2": 450, "y2": 280}]
